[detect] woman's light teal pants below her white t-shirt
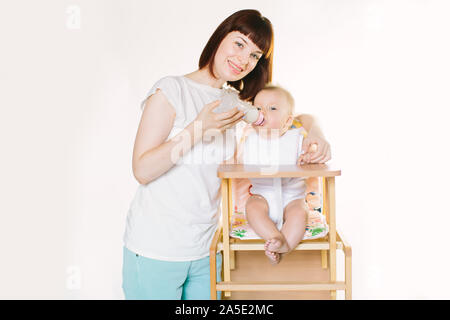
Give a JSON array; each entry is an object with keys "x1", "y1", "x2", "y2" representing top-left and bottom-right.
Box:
[{"x1": 122, "y1": 247, "x2": 222, "y2": 300}]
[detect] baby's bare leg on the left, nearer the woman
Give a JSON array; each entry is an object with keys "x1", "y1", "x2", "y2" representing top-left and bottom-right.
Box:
[{"x1": 245, "y1": 195, "x2": 289, "y2": 253}]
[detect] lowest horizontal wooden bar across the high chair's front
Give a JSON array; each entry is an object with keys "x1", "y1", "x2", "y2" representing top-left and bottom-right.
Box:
[{"x1": 216, "y1": 281, "x2": 346, "y2": 291}]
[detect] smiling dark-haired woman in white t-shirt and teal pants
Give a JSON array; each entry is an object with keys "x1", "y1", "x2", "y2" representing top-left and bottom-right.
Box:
[{"x1": 123, "y1": 10, "x2": 330, "y2": 299}]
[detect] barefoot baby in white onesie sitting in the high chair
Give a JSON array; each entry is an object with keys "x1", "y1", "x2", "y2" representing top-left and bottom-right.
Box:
[{"x1": 238, "y1": 86, "x2": 307, "y2": 264}]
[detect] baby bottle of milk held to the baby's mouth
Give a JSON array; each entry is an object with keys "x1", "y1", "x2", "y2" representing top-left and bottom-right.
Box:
[{"x1": 214, "y1": 89, "x2": 264, "y2": 126}]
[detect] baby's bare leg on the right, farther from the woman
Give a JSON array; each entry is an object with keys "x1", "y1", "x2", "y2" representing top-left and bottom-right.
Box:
[{"x1": 281, "y1": 199, "x2": 307, "y2": 254}]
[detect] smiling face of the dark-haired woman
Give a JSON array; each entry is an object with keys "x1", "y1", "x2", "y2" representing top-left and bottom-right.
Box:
[{"x1": 213, "y1": 31, "x2": 263, "y2": 82}]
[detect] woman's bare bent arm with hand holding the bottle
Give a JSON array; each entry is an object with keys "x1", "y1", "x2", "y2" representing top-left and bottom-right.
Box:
[{"x1": 132, "y1": 90, "x2": 243, "y2": 184}]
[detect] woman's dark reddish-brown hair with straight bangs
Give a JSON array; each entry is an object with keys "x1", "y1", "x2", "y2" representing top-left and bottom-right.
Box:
[{"x1": 198, "y1": 10, "x2": 273, "y2": 100}]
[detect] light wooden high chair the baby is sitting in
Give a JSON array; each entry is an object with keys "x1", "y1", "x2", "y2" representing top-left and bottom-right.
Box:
[{"x1": 210, "y1": 164, "x2": 352, "y2": 300}]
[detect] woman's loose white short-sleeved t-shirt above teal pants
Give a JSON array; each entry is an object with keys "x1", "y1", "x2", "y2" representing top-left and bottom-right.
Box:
[{"x1": 124, "y1": 76, "x2": 235, "y2": 261}]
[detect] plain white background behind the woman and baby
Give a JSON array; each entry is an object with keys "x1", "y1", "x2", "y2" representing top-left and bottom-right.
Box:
[{"x1": 0, "y1": 0, "x2": 450, "y2": 299}]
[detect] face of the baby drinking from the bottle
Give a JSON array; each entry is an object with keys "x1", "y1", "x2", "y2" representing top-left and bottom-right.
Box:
[{"x1": 253, "y1": 90, "x2": 291, "y2": 131}]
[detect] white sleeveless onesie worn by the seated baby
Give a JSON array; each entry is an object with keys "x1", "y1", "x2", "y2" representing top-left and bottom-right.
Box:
[{"x1": 242, "y1": 129, "x2": 306, "y2": 229}]
